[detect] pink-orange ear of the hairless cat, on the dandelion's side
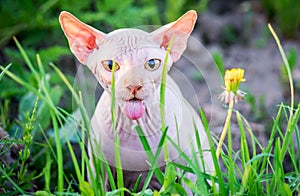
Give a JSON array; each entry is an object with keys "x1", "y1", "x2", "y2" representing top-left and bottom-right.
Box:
[{"x1": 151, "y1": 10, "x2": 197, "y2": 62}]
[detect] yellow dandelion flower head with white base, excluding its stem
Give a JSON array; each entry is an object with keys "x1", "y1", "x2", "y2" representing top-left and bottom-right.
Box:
[{"x1": 219, "y1": 68, "x2": 246, "y2": 103}]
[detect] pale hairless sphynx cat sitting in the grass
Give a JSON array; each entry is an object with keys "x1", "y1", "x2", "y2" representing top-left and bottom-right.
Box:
[{"x1": 59, "y1": 10, "x2": 214, "y2": 193}]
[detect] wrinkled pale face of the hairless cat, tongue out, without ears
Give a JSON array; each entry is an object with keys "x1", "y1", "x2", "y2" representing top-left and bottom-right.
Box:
[{"x1": 87, "y1": 29, "x2": 172, "y2": 120}]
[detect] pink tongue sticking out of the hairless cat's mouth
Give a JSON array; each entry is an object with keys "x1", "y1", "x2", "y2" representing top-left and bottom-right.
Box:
[{"x1": 125, "y1": 100, "x2": 145, "y2": 120}]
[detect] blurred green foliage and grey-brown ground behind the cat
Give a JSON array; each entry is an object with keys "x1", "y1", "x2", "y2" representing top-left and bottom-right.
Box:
[{"x1": 0, "y1": 0, "x2": 300, "y2": 193}]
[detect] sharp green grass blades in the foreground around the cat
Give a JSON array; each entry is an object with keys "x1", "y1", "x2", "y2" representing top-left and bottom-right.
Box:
[{"x1": 0, "y1": 26, "x2": 300, "y2": 195}]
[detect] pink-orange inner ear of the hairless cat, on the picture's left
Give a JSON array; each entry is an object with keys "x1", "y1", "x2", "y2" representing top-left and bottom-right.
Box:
[{"x1": 59, "y1": 11, "x2": 106, "y2": 64}]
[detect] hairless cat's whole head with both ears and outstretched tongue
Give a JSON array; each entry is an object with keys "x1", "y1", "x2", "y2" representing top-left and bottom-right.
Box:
[{"x1": 59, "y1": 10, "x2": 197, "y2": 120}]
